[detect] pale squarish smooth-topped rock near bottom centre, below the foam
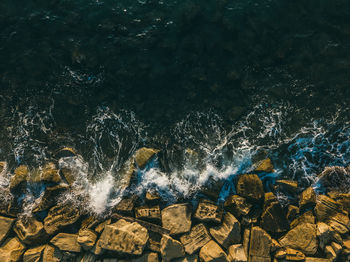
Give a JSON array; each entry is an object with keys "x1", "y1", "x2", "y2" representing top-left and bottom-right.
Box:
[{"x1": 162, "y1": 204, "x2": 192, "y2": 235}]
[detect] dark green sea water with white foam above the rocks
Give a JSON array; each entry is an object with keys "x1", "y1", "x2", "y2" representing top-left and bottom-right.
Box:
[{"x1": 0, "y1": 0, "x2": 350, "y2": 212}]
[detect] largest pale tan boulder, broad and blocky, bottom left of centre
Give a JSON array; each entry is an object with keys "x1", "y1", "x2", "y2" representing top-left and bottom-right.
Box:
[{"x1": 99, "y1": 219, "x2": 149, "y2": 255}]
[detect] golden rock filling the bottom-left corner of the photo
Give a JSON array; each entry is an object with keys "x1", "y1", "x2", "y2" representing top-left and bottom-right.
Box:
[{"x1": 0, "y1": 237, "x2": 25, "y2": 262}]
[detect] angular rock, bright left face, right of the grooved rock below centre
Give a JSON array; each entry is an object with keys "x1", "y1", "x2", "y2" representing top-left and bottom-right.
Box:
[{"x1": 210, "y1": 212, "x2": 241, "y2": 248}]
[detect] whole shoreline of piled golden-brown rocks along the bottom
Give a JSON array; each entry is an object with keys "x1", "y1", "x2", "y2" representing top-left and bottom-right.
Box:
[{"x1": 0, "y1": 148, "x2": 350, "y2": 262}]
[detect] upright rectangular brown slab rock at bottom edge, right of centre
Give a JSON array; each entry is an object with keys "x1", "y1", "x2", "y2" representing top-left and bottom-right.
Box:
[{"x1": 248, "y1": 226, "x2": 272, "y2": 262}]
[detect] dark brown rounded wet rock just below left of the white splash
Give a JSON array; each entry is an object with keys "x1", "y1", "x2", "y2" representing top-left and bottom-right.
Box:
[{"x1": 44, "y1": 205, "x2": 80, "y2": 235}]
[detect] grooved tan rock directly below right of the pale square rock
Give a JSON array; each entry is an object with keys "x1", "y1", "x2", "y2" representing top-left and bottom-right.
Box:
[{"x1": 180, "y1": 224, "x2": 211, "y2": 255}]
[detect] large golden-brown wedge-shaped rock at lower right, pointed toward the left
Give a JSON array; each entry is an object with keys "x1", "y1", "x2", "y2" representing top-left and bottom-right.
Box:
[{"x1": 279, "y1": 223, "x2": 318, "y2": 255}]
